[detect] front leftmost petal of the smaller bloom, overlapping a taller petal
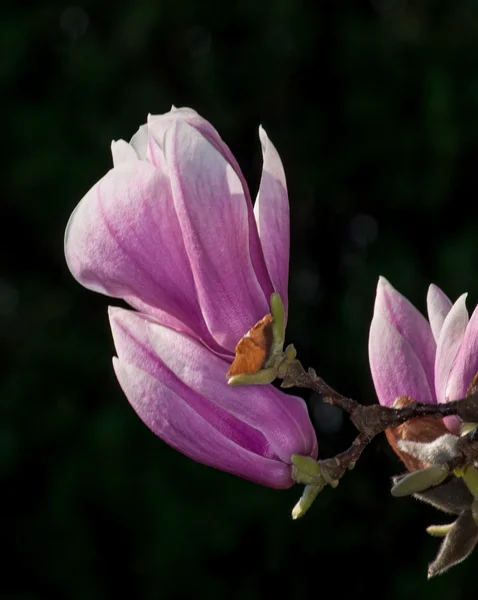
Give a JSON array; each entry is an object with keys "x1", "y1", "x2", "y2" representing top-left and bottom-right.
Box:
[{"x1": 369, "y1": 312, "x2": 435, "y2": 406}]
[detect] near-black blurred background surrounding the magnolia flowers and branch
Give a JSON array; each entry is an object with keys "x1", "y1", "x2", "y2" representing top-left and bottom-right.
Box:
[{"x1": 0, "y1": 0, "x2": 478, "y2": 600}]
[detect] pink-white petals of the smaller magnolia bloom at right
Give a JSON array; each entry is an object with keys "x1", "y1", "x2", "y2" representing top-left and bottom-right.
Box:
[{"x1": 369, "y1": 277, "x2": 478, "y2": 433}]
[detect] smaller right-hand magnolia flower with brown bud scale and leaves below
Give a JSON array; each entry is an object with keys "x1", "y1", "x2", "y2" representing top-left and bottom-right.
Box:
[{"x1": 369, "y1": 277, "x2": 478, "y2": 577}]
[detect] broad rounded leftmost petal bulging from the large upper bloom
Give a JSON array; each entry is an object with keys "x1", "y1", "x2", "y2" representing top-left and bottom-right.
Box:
[{"x1": 65, "y1": 161, "x2": 217, "y2": 347}]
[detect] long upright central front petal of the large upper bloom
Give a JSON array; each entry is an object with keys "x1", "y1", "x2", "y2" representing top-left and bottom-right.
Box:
[{"x1": 163, "y1": 121, "x2": 269, "y2": 351}]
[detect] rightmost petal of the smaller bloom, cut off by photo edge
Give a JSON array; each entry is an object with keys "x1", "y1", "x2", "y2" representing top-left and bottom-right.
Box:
[{"x1": 446, "y1": 307, "x2": 478, "y2": 400}]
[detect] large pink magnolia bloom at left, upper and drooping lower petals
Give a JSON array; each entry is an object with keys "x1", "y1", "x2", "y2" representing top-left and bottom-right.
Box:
[{"x1": 65, "y1": 108, "x2": 317, "y2": 488}]
